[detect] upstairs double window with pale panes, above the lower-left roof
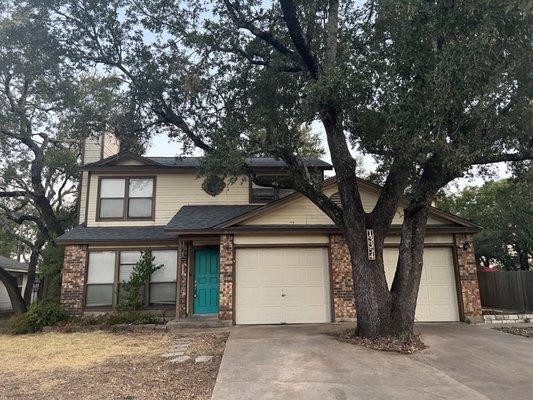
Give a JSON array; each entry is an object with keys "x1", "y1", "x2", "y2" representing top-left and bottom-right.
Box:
[{"x1": 98, "y1": 177, "x2": 155, "y2": 220}]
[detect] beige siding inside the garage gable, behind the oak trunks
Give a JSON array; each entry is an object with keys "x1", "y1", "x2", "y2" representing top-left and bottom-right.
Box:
[{"x1": 243, "y1": 186, "x2": 444, "y2": 225}]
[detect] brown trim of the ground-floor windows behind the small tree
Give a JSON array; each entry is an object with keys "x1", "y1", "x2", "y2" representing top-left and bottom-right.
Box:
[{"x1": 83, "y1": 246, "x2": 181, "y2": 311}]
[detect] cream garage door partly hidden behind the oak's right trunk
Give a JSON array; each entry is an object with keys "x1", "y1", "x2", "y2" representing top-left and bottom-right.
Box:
[{"x1": 384, "y1": 247, "x2": 459, "y2": 322}]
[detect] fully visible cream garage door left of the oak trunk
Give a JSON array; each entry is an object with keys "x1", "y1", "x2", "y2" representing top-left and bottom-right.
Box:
[{"x1": 235, "y1": 247, "x2": 331, "y2": 324}]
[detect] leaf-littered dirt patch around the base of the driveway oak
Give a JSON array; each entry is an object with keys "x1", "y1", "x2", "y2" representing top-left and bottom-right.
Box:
[{"x1": 333, "y1": 329, "x2": 427, "y2": 354}]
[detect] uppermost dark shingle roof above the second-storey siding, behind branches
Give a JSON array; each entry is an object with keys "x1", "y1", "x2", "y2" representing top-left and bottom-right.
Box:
[{"x1": 80, "y1": 152, "x2": 333, "y2": 170}]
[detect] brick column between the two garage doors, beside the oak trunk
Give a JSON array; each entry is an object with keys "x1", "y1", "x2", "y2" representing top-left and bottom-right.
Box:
[{"x1": 329, "y1": 234, "x2": 355, "y2": 320}]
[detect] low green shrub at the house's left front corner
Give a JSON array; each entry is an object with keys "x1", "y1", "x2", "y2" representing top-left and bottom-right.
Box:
[{"x1": 10, "y1": 302, "x2": 70, "y2": 334}]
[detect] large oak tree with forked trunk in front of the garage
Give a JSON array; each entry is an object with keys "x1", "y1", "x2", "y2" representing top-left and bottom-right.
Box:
[{"x1": 38, "y1": 0, "x2": 532, "y2": 337}]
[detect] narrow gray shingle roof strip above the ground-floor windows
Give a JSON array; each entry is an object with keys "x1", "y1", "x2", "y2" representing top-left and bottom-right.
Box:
[{"x1": 56, "y1": 225, "x2": 176, "y2": 243}]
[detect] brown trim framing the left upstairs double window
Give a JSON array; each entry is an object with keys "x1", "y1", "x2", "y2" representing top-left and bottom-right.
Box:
[{"x1": 95, "y1": 175, "x2": 157, "y2": 221}]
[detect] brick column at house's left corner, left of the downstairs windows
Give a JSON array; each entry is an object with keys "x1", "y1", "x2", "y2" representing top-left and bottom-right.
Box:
[{"x1": 61, "y1": 245, "x2": 87, "y2": 316}]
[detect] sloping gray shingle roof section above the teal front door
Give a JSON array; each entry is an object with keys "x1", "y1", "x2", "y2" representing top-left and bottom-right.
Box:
[{"x1": 165, "y1": 205, "x2": 261, "y2": 231}]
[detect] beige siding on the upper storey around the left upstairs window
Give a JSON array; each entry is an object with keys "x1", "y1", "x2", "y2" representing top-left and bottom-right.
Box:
[{"x1": 87, "y1": 173, "x2": 248, "y2": 226}]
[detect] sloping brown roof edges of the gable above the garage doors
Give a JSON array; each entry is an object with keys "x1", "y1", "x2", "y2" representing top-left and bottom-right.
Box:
[{"x1": 214, "y1": 176, "x2": 481, "y2": 231}]
